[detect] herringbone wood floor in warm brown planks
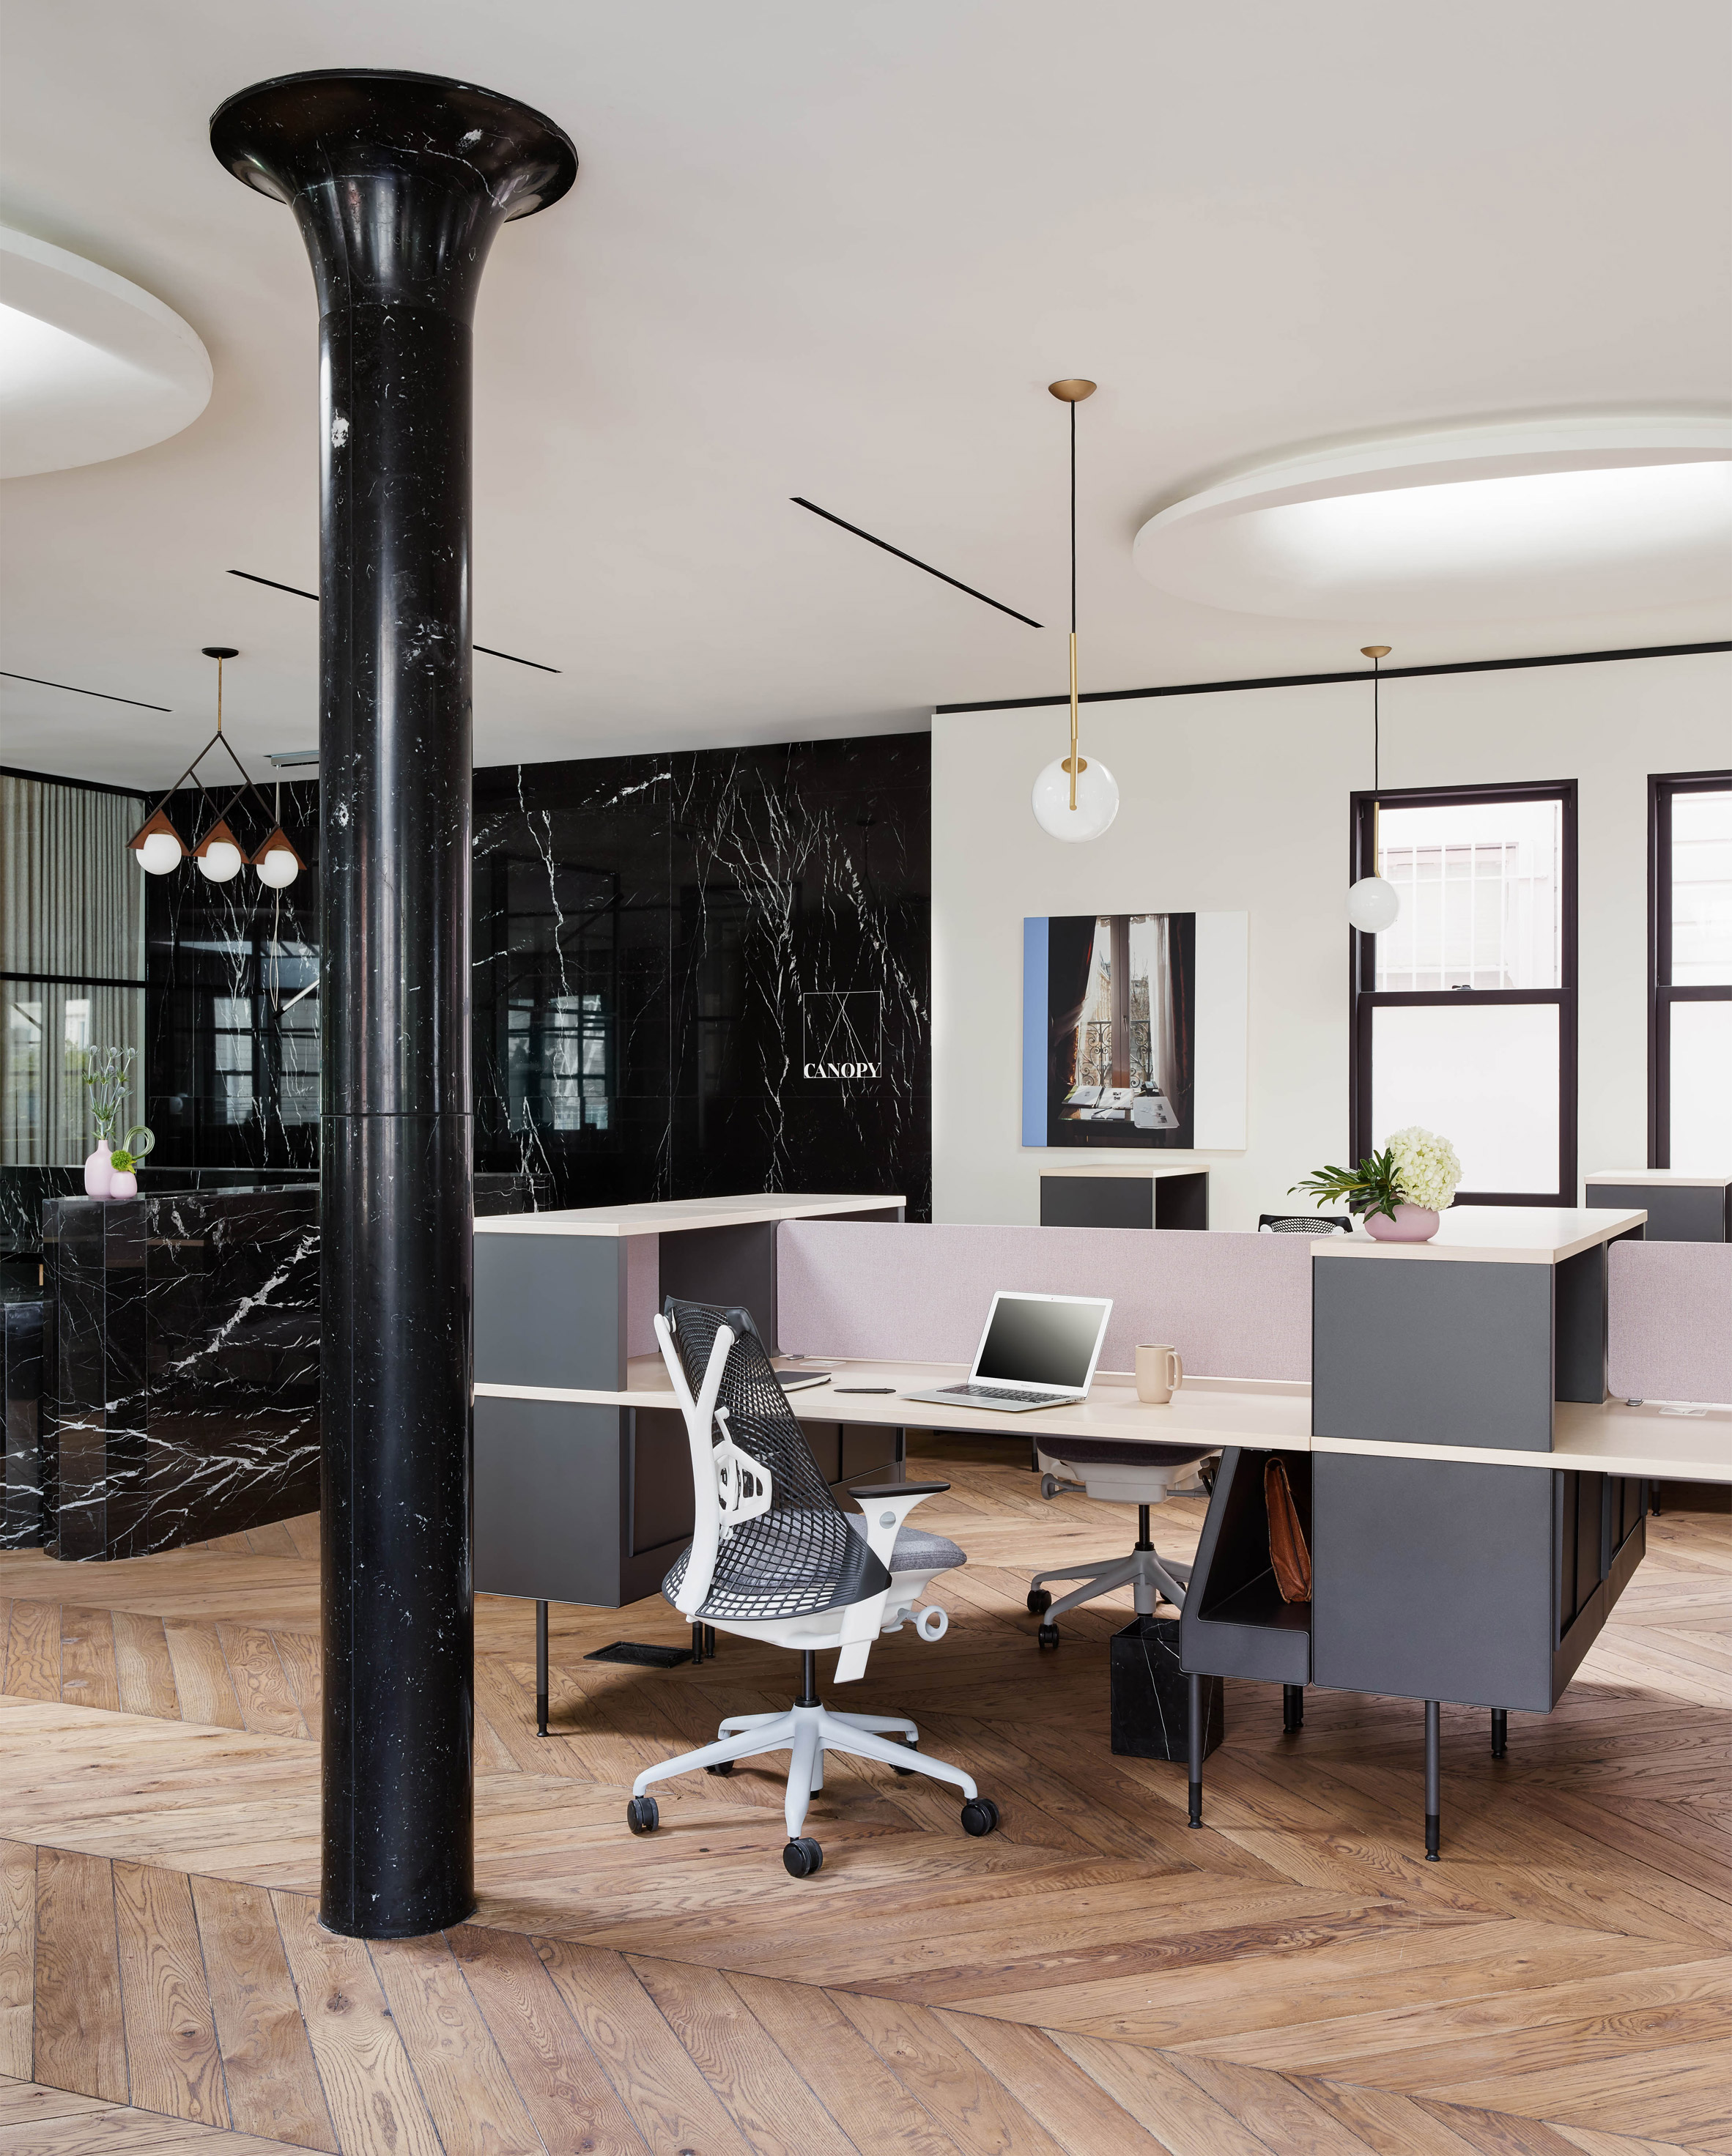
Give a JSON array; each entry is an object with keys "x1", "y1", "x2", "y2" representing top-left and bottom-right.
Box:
[{"x1": 0, "y1": 1445, "x2": 1732, "y2": 2156}]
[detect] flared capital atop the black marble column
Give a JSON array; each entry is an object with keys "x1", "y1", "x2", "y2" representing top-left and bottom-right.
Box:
[{"x1": 212, "y1": 67, "x2": 578, "y2": 322}]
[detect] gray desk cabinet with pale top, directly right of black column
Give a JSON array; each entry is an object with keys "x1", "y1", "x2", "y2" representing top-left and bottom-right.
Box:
[{"x1": 475, "y1": 1196, "x2": 902, "y2": 1722}]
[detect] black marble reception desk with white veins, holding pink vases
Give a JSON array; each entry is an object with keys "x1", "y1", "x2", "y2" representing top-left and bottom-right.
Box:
[{"x1": 25, "y1": 1175, "x2": 541, "y2": 1559}]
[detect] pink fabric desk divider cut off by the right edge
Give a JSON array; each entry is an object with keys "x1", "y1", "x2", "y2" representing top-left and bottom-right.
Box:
[{"x1": 1605, "y1": 1242, "x2": 1732, "y2": 1406}]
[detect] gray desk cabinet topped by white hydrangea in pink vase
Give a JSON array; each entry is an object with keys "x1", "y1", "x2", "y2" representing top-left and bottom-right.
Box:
[{"x1": 1180, "y1": 1207, "x2": 1648, "y2": 1856}]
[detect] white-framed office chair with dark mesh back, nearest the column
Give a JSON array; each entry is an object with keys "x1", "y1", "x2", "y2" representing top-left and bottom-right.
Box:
[{"x1": 626, "y1": 1296, "x2": 999, "y2": 1878}]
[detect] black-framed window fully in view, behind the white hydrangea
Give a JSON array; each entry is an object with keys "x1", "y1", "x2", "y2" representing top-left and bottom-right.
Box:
[{"x1": 1348, "y1": 780, "x2": 1577, "y2": 1205}]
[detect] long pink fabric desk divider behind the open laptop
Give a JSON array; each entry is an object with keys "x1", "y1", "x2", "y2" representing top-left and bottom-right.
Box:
[{"x1": 777, "y1": 1220, "x2": 1311, "y2": 1382}]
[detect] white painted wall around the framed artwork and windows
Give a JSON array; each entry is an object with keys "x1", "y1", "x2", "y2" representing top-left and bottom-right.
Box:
[{"x1": 932, "y1": 653, "x2": 1732, "y2": 1227}]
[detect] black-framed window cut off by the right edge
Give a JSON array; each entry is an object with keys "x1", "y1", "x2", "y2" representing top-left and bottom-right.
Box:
[{"x1": 1648, "y1": 772, "x2": 1732, "y2": 1175}]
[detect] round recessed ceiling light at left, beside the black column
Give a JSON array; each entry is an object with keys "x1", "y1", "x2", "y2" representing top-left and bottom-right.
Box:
[{"x1": 0, "y1": 226, "x2": 212, "y2": 478}]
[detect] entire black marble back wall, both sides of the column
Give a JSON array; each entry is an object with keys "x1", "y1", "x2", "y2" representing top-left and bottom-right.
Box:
[{"x1": 135, "y1": 733, "x2": 932, "y2": 1218}]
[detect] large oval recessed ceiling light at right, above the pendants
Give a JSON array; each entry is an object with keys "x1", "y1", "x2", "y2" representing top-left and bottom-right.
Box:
[{"x1": 1135, "y1": 414, "x2": 1732, "y2": 621}]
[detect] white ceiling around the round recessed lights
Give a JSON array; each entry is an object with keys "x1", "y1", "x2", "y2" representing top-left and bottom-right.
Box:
[{"x1": 0, "y1": 0, "x2": 1732, "y2": 785}]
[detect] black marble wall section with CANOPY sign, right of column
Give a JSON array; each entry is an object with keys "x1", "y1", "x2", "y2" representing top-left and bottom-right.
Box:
[{"x1": 475, "y1": 733, "x2": 932, "y2": 1218}]
